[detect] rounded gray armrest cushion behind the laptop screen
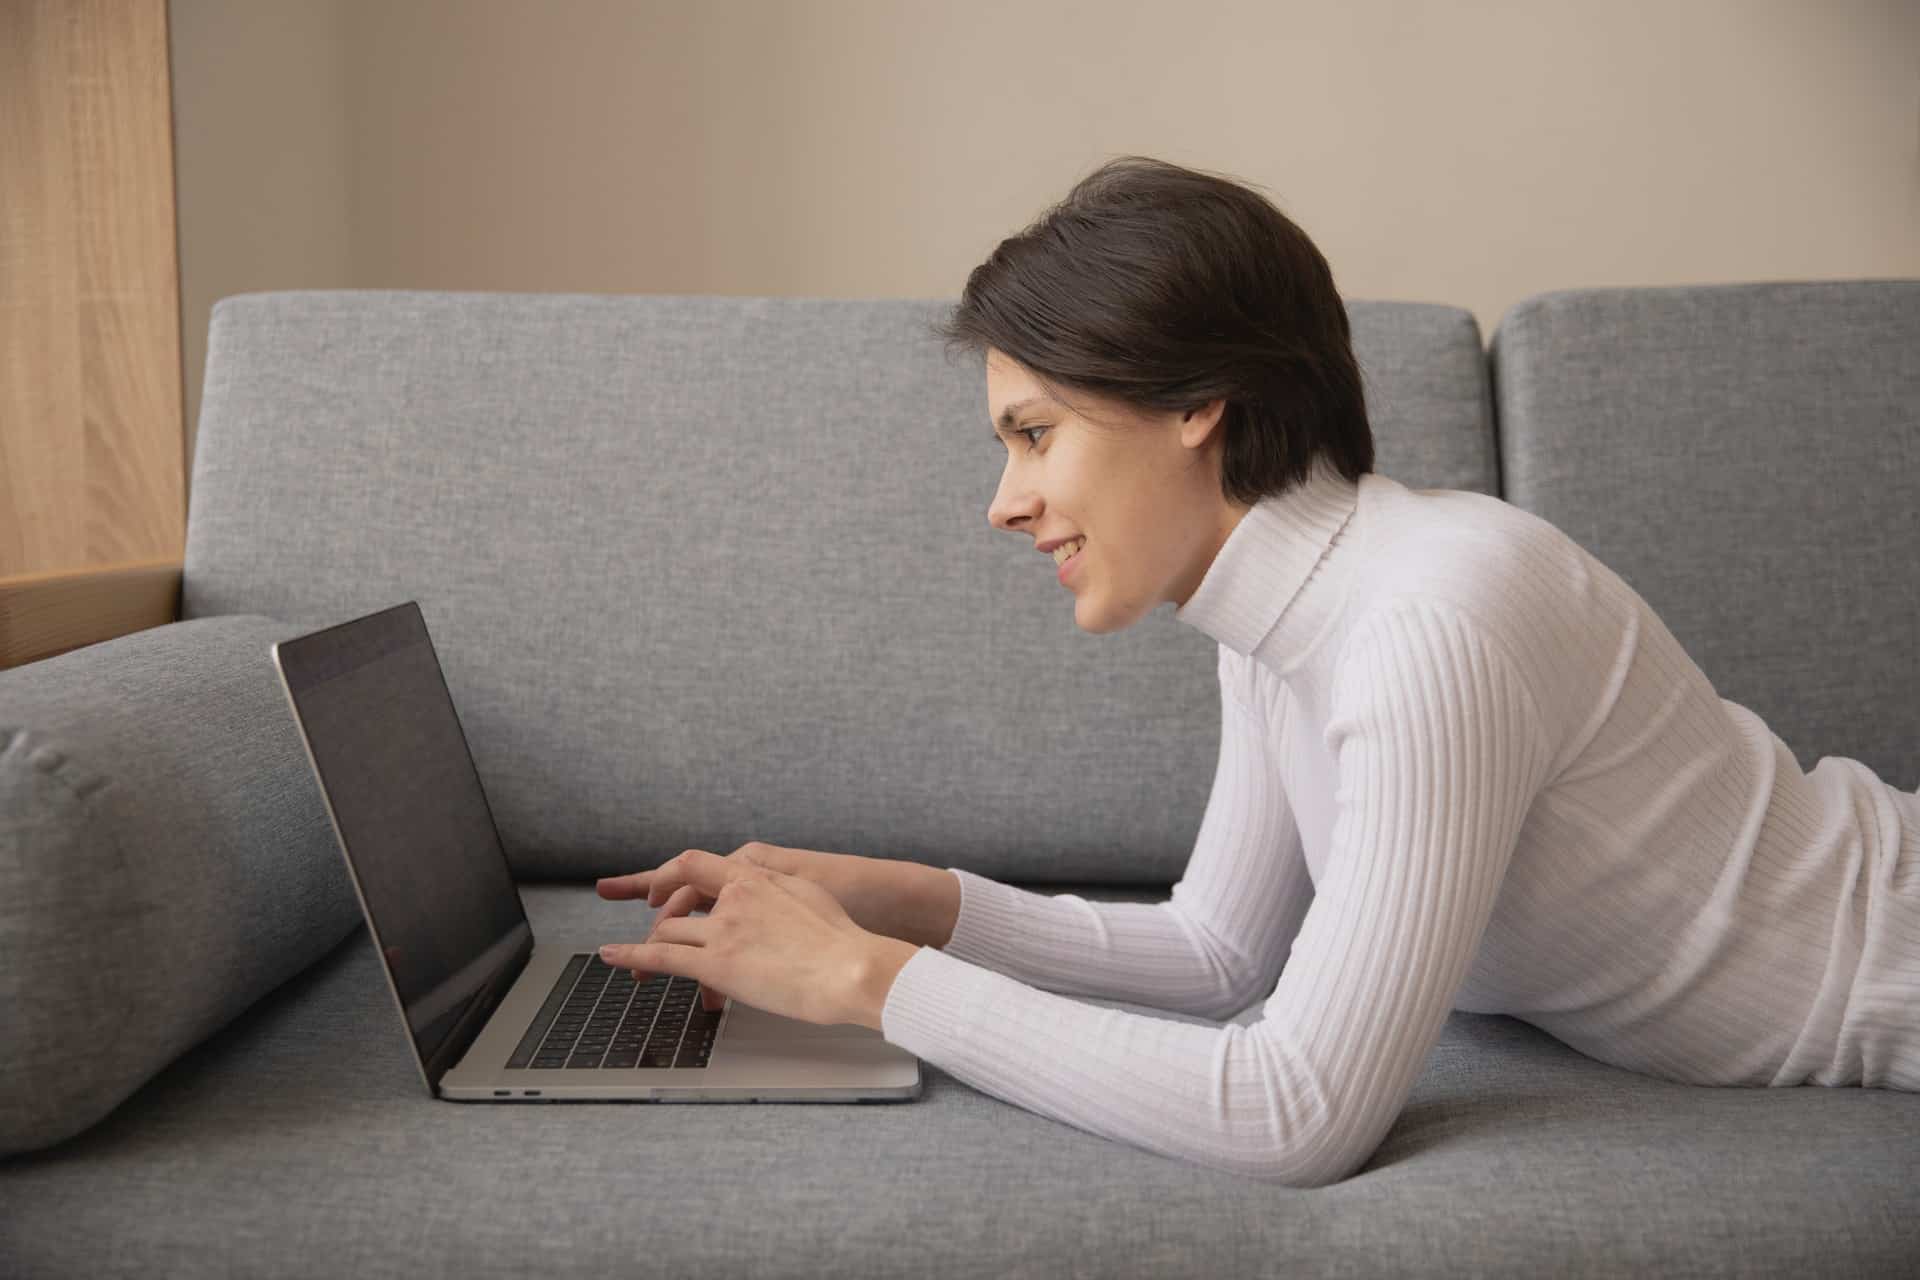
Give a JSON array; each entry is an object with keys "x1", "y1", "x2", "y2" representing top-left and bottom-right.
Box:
[{"x1": 0, "y1": 616, "x2": 361, "y2": 1151}]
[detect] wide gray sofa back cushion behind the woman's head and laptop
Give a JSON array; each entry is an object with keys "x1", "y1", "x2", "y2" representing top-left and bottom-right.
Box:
[{"x1": 182, "y1": 292, "x2": 1494, "y2": 883}]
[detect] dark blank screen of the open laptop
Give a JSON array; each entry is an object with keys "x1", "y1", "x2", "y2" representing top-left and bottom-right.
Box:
[{"x1": 276, "y1": 601, "x2": 532, "y2": 1086}]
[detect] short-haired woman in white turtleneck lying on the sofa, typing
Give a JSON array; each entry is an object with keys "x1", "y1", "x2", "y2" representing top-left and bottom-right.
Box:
[{"x1": 599, "y1": 157, "x2": 1920, "y2": 1186}]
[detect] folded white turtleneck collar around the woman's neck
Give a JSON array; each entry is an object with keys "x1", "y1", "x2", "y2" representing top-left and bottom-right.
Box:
[{"x1": 1173, "y1": 459, "x2": 1359, "y2": 670}]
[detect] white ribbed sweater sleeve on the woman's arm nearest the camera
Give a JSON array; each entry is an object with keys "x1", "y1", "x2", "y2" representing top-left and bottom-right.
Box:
[{"x1": 881, "y1": 599, "x2": 1553, "y2": 1186}]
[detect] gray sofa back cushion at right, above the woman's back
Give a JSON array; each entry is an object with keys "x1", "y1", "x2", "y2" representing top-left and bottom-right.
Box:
[{"x1": 1490, "y1": 280, "x2": 1920, "y2": 791}]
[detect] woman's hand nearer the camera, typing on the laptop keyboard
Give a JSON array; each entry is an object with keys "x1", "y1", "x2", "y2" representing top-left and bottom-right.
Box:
[{"x1": 601, "y1": 848, "x2": 876, "y2": 1025}]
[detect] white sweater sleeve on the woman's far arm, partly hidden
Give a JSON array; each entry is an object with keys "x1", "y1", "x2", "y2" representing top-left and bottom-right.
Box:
[{"x1": 941, "y1": 645, "x2": 1313, "y2": 1019}]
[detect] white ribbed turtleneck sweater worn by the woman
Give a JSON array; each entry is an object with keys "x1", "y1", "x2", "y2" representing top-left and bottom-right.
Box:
[{"x1": 881, "y1": 458, "x2": 1920, "y2": 1186}]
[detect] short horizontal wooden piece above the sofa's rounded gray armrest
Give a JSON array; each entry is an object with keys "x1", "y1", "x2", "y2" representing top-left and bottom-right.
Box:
[{"x1": 0, "y1": 560, "x2": 180, "y2": 668}]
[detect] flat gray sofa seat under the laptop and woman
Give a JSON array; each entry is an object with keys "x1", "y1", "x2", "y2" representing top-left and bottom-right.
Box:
[{"x1": 0, "y1": 885, "x2": 1920, "y2": 1280}]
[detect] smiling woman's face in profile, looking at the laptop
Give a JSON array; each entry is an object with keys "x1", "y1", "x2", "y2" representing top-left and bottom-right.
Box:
[{"x1": 987, "y1": 349, "x2": 1246, "y2": 633}]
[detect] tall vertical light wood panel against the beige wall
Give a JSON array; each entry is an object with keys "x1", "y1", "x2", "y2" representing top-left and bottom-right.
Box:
[{"x1": 0, "y1": 0, "x2": 186, "y2": 576}]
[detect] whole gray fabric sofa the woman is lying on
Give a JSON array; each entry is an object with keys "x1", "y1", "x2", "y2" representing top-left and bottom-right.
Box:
[{"x1": 0, "y1": 280, "x2": 1920, "y2": 1278}]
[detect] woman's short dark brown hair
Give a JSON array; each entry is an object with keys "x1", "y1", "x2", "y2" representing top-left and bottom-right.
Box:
[{"x1": 933, "y1": 155, "x2": 1373, "y2": 507}]
